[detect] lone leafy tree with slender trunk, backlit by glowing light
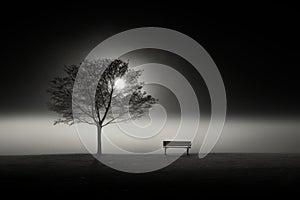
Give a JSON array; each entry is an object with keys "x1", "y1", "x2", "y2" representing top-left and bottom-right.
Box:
[{"x1": 47, "y1": 59, "x2": 157, "y2": 155}]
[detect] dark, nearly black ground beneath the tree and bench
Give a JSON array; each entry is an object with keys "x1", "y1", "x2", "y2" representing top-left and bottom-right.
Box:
[{"x1": 0, "y1": 154, "x2": 300, "y2": 198}]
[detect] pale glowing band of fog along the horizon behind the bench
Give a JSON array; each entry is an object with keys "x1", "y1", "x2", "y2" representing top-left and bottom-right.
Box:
[{"x1": 0, "y1": 115, "x2": 300, "y2": 155}]
